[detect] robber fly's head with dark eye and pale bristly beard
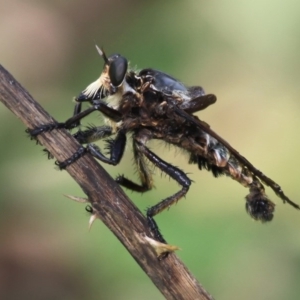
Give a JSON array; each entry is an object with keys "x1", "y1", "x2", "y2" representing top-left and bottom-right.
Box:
[{"x1": 75, "y1": 46, "x2": 128, "y2": 102}]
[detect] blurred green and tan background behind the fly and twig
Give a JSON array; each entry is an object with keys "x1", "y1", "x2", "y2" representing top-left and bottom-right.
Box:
[{"x1": 0, "y1": 0, "x2": 300, "y2": 300}]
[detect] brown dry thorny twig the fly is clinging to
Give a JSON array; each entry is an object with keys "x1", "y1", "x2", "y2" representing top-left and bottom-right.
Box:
[{"x1": 0, "y1": 65, "x2": 212, "y2": 300}]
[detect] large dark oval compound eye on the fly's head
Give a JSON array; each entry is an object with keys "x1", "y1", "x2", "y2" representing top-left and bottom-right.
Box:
[{"x1": 108, "y1": 55, "x2": 128, "y2": 87}]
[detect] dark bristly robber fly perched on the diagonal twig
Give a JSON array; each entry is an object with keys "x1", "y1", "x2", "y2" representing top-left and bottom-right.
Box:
[{"x1": 28, "y1": 47, "x2": 300, "y2": 242}]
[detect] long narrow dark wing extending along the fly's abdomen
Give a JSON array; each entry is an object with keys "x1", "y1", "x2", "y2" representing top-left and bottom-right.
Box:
[{"x1": 174, "y1": 106, "x2": 300, "y2": 209}]
